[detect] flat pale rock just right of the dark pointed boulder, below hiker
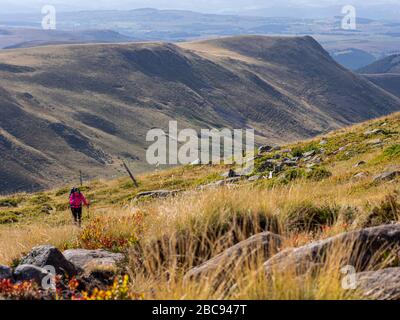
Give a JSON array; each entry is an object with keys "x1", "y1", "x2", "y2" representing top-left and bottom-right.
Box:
[{"x1": 63, "y1": 249, "x2": 124, "y2": 271}]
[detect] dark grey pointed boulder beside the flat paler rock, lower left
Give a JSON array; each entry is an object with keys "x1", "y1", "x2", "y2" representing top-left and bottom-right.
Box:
[{"x1": 20, "y1": 245, "x2": 79, "y2": 277}]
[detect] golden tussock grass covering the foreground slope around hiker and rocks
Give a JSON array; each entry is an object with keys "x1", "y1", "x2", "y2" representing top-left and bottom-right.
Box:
[{"x1": 0, "y1": 114, "x2": 400, "y2": 299}]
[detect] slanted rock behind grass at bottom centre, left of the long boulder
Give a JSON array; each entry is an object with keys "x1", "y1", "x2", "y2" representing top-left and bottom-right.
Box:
[{"x1": 185, "y1": 232, "x2": 282, "y2": 280}]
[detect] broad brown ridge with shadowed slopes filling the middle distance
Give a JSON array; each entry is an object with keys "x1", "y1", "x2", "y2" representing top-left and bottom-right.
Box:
[{"x1": 0, "y1": 36, "x2": 400, "y2": 193}]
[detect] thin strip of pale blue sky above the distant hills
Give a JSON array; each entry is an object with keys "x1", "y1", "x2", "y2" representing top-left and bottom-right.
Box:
[{"x1": 0, "y1": 0, "x2": 400, "y2": 14}]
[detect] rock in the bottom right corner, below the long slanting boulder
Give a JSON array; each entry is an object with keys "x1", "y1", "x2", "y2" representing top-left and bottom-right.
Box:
[{"x1": 356, "y1": 268, "x2": 400, "y2": 300}]
